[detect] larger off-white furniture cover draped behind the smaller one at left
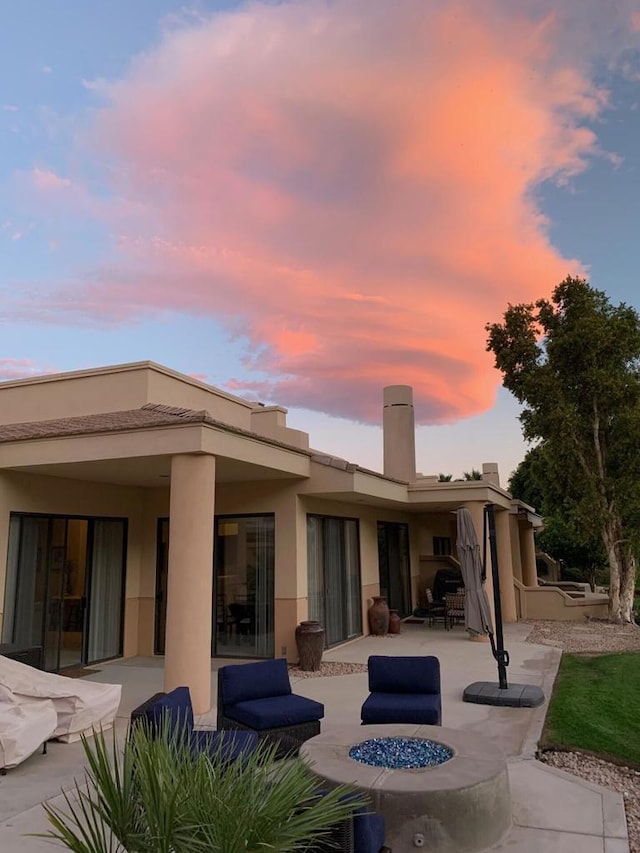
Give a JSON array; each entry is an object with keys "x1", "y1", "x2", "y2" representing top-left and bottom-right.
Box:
[{"x1": 0, "y1": 655, "x2": 122, "y2": 742}]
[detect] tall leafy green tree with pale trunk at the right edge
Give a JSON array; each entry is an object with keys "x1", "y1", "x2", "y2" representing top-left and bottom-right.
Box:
[{"x1": 486, "y1": 277, "x2": 640, "y2": 622}]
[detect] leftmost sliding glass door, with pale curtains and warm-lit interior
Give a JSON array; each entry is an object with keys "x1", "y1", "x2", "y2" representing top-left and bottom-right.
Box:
[{"x1": 2, "y1": 514, "x2": 126, "y2": 672}]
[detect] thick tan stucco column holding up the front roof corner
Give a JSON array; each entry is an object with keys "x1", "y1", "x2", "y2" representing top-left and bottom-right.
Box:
[{"x1": 164, "y1": 454, "x2": 216, "y2": 714}]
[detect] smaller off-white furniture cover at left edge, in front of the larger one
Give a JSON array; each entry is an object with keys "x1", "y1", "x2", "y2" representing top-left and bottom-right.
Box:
[{"x1": 0, "y1": 688, "x2": 58, "y2": 770}]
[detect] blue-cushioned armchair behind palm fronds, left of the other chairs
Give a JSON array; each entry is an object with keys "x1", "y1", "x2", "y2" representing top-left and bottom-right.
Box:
[{"x1": 131, "y1": 687, "x2": 258, "y2": 762}]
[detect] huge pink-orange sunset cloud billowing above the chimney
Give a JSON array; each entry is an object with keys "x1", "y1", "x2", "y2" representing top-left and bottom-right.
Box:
[{"x1": 15, "y1": 0, "x2": 631, "y2": 423}]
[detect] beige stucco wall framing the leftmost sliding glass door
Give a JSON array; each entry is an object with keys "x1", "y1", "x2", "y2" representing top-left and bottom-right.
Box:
[{"x1": 0, "y1": 472, "x2": 155, "y2": 656}]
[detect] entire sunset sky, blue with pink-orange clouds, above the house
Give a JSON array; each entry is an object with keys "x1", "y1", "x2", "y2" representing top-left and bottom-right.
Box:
[{"x1": 0, "y1": 0, "x2": 640, "y2": 484}]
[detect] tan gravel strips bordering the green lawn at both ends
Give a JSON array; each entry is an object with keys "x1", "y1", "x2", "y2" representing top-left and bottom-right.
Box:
[{"x1": 527, "y1": 619, "x2": 640, "y2": 853}]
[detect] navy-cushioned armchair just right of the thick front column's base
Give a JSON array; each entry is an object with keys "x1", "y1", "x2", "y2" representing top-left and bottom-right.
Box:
[{"x1": 218, "y1": 658, "x2": 324, "y2": 755}]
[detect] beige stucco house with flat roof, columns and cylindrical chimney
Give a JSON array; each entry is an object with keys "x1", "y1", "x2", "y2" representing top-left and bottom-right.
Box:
[{"x1": 0, "y1": 362, "x2": 608, "y2": 712}]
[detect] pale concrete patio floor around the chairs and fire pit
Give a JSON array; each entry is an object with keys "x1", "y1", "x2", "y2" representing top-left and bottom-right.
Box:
[{"x1": 0, "y1": 624, "x2": 629, "y2": 853}]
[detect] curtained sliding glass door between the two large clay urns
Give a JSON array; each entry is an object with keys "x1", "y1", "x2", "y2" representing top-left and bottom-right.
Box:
[{"x1": 307, "y1": 515, "x2": 362, "y2": 646}]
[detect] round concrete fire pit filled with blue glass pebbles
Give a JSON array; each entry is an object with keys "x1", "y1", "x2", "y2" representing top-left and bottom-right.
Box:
[{"x1": 300, "y1": 725, "x2": 511, "y2": 853}]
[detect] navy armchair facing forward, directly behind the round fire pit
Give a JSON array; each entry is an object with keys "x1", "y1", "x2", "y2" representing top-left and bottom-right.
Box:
[{"x1": 360, "y1": 655, "x2": 442, "y2": 726}]
